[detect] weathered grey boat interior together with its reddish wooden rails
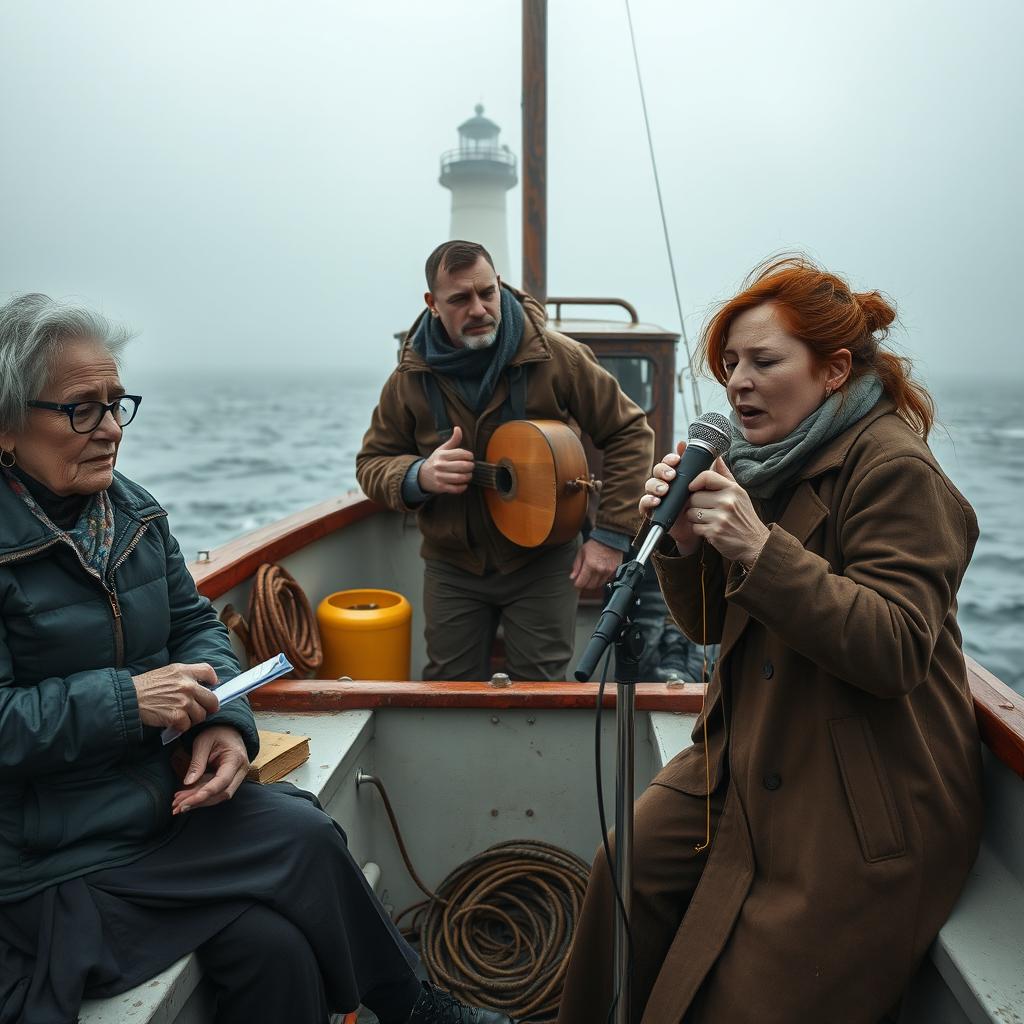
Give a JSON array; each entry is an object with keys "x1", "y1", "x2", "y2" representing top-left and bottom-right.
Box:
[{"x1": 81, "y1": 496, "x2": 1024, "y2": 1024}]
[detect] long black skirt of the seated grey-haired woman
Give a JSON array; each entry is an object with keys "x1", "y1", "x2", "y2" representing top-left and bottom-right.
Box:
[{"x1": 0, "y1": 782, "x2": 419, "y2": 1024}]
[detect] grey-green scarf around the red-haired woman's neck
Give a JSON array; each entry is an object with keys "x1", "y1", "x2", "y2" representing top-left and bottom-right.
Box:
[{"x1": 729, "y1": 372, "x2": 883, "y2": 498}]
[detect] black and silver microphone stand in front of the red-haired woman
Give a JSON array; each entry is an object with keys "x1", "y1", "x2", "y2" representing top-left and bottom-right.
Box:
[{"x1": 574, "y1": 524, "x2": 665, "y2": 1024}]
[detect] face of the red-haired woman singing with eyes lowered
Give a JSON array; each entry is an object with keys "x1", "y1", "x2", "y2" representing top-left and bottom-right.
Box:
[{"x1": 723, "y1": 303, "x2": 835, "y2": 444}]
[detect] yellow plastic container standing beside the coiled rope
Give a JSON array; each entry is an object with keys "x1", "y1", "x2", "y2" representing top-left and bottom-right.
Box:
[{"x1": 316, "y1": 590, "x2": 413, "y2": 679}]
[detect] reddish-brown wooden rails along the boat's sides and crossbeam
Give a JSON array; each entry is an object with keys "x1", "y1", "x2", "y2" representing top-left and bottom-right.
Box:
[{"x1": 189, "y1": 492, "x2": 1024, "y2": 778}]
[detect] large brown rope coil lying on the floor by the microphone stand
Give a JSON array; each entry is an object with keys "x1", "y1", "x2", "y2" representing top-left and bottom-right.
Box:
[{"x1": 411, "y1": 840, "x2": 590, "y2": 1022}]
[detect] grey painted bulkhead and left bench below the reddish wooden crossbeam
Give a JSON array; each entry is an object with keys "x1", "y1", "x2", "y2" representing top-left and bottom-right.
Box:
[{"x1": 80, "y1": 704, "x2": 694, "y2": 1024}]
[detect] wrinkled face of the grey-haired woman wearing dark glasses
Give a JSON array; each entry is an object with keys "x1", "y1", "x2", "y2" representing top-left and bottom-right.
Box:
[{"x1": 0, "y1": 338, "x2": 125, "y2": 496}]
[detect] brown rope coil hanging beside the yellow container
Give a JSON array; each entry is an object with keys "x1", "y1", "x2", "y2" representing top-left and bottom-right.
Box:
[{"x1": 220, "y1": 562, "x2": 324, "y2": 679}]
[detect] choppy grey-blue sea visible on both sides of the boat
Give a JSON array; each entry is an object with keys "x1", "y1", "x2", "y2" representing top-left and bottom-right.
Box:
[{"x1": 118, "y1": 371, "x2": 1024, "y2": 692}]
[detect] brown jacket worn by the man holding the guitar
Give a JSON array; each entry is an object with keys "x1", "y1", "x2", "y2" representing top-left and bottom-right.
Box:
[{"x1": 355, "y1": 286, "x2": 654, "y2": 573}]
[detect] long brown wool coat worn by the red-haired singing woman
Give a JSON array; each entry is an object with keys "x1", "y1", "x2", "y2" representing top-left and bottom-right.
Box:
[{"x1": 637, "y1": 399, "x2": 982, "y2": 1024}]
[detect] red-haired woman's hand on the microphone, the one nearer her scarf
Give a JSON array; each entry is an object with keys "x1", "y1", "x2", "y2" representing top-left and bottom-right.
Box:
[{"x1": 679, "y1": 459, "x2": 771, "y2": 568}]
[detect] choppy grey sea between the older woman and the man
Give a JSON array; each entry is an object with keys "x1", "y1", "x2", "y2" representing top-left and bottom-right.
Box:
[{"x1": 118, "y1": 372, "x2": 383, "y2": 560}]
